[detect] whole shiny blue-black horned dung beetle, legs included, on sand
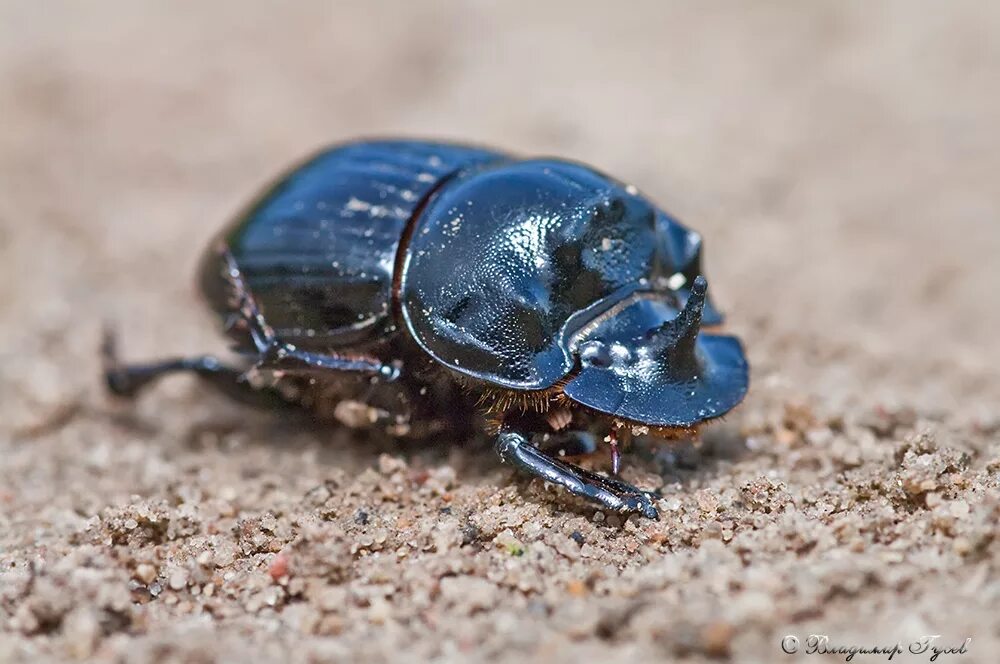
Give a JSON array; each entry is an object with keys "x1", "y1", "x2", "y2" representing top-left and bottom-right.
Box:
[{"x1": 105, "y1": 140, "x2": 749, "y2": 518}]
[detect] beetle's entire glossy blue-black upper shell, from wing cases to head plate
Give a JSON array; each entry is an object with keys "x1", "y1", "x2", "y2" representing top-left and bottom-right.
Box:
[{"x1": 201, "y1": 141, "x2": 748, "y2": 426}]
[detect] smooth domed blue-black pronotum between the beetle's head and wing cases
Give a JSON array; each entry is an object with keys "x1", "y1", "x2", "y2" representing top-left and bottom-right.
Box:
[{"x1": 401, "y1": 159, "x2": 719, "y2": 390}]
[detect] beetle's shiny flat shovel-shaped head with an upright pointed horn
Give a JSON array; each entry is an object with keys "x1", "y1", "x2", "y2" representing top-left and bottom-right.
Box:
[{"x1": 563, "y1": 276, "x2": 749, "y2": 429}]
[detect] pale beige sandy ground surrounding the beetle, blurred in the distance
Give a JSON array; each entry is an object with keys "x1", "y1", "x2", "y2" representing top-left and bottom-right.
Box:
[{"x1": 0, "y1": 0, "x2": 1000, "y2": 662}]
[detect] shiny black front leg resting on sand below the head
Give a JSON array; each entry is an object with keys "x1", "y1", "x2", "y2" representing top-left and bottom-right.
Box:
[{"x1": 495, "y1": 424, "x2": 659, "y2": 519}]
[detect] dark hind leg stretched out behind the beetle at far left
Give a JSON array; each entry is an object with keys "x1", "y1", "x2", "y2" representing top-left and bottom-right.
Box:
[{"x1": 101, "y1": 330, "x2": 286, "y2": 406}]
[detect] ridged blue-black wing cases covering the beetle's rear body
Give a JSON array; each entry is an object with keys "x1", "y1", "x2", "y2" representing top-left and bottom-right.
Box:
[{"x1": 201, "y1": 141, "x2": 502, "y2": 350}]
